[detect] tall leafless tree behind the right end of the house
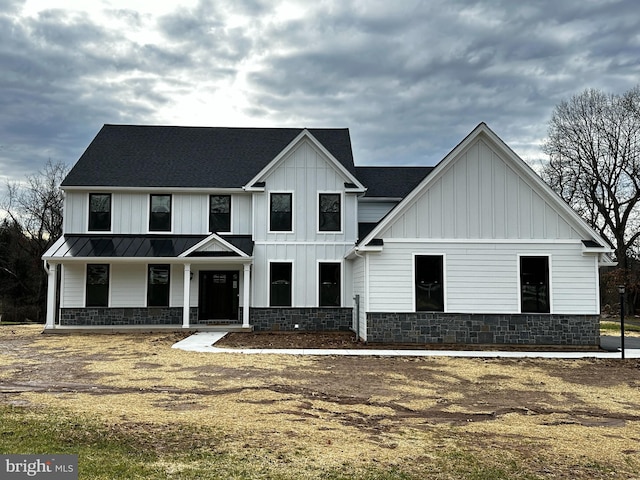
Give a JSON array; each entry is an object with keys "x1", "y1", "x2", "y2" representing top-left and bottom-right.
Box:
[{"x1": 542, "y1": 86, "x2": 640, "y2": 271}]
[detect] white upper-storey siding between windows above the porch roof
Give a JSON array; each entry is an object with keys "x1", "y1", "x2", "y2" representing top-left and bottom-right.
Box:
[{"x1": 64, "y1": 190, "x2": 252, "y2": 235}]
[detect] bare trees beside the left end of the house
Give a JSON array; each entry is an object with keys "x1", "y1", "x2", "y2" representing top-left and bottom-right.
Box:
[{"x1": 0, "y1": 160, "x2": 68, "y2": 321}]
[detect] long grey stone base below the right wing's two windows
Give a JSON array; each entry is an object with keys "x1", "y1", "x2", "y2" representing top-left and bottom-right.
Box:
[{"x1": 367, "y1": 312, "x2": 600, "y2": 346}]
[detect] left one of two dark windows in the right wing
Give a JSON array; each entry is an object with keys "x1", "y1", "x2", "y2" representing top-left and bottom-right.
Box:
[{"x1": 415, "y1": 255, "x2": 444, "y2": 312}]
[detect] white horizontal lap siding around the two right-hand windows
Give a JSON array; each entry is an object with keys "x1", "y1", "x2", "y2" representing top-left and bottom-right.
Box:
[{"x1": 368, "y1": 240, "x2": 599, "y2": 314}]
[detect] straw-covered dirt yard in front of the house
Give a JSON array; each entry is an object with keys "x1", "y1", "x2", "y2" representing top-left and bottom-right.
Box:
[{"x1": 0, "y1": 327, "x2": 640, "y2": 479}]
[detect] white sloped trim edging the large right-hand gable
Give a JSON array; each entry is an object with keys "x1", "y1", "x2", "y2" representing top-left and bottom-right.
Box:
[{"x1": 356, "y1": 122, "x2": 612, "y2": 255}]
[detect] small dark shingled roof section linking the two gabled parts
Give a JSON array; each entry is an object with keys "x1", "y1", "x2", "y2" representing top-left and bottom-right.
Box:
[{"x1": 356, "y1": 167, "x2": 435, "y2": 198}]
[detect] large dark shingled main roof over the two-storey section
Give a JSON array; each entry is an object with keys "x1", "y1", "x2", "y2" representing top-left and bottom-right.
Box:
[{"x1": 62, "y1": 125, "x2": 355, "y2": 188}]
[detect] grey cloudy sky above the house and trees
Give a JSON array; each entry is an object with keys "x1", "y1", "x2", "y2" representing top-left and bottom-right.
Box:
[{"x1": 0, "y1": 0, "x2": 640, "y2": 193}]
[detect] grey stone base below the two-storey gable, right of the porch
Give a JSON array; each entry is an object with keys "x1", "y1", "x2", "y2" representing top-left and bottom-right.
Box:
[{"x1": 249, "y1": 307, "x2": 353, "y2": 332}]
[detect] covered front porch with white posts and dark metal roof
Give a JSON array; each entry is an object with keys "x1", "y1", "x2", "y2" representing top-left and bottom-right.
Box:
[{"x1": 45, "y1": 234, "x2": 253, "y2": 331}]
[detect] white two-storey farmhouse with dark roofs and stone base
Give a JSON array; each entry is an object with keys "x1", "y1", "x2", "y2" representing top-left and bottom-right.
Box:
[{"x1": 43, "y1": 124, "x2": 612, "y2": 345}]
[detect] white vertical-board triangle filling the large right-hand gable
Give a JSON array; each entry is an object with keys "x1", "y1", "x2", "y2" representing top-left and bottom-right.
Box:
[{"x1": 381, "y1": 139, "x2": 581, "y2": 239}]
